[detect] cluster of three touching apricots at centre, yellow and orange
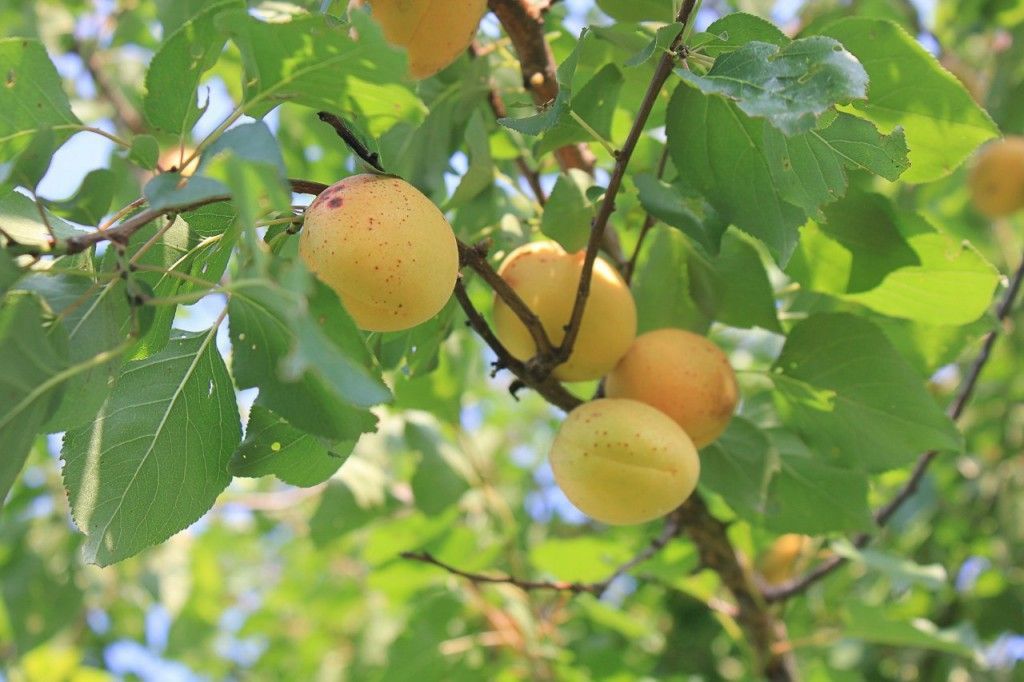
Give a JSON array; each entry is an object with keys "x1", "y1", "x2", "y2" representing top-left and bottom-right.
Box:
[{"x1": 485, "y1": 242, "x2": 738, "y2": 524}]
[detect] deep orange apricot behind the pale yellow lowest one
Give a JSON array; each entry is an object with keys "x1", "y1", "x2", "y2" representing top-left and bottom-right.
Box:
[{"x1": 604, "y1": 329, "x2": 739, "y2": 447}]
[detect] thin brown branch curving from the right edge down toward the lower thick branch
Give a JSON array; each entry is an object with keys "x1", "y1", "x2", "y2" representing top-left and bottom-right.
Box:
[{"x1": 764, "y1": 249, "x2": 1024, "y2": 601}]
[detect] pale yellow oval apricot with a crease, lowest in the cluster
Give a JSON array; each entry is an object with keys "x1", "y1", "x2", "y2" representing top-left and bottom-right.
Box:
[{"x1": 551, "y1": 398, "x2": 700, "y2": 525}]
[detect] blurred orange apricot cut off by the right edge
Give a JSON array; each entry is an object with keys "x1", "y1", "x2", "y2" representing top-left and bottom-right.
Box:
[{"x1": 968, "y1": 135, "x2": 1024, "y2": 218}]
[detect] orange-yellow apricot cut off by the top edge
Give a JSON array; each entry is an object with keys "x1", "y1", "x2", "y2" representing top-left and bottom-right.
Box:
[{"x1": 369, "y1": 0, "x2": 487, "y2": 78}]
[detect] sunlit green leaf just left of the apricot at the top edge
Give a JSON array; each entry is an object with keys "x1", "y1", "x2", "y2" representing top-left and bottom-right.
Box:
[{"x1": 216, "y1": 10, "x2": 423, "y2": 120}]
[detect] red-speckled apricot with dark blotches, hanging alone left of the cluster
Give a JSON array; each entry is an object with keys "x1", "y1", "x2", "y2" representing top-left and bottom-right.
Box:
[{"x1": 299, "y1": 174, "x2": 459, "y2": 332}]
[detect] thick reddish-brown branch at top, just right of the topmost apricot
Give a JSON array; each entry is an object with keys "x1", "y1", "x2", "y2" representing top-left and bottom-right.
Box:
[{"x1": 487, "y1": 0, "x2": 594, "y2": 174}]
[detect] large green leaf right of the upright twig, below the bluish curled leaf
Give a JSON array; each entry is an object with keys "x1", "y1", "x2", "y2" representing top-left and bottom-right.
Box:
[{"x1": 668, "y1": 85, "x2": 805, "y2": 262}]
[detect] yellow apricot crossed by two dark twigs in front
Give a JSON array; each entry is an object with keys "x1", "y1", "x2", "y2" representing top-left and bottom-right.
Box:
[{"x1": 494, "y1": 242, "x2": 637, "y2": 381}]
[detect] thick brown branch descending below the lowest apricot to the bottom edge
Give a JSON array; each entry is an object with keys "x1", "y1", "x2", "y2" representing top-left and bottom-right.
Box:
[{"x1": 680, "y1": 493, "x2": 797, "y2": 680}]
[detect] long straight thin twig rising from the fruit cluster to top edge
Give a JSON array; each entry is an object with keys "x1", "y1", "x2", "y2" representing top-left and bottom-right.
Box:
[{"x1": 553, "y1": 0, "x2": 696, "y2": 367}]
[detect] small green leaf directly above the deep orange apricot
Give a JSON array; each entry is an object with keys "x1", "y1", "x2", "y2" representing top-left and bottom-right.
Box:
[{"x1": 633, "y1": 227, "x2": 712, "y2": 334}]
